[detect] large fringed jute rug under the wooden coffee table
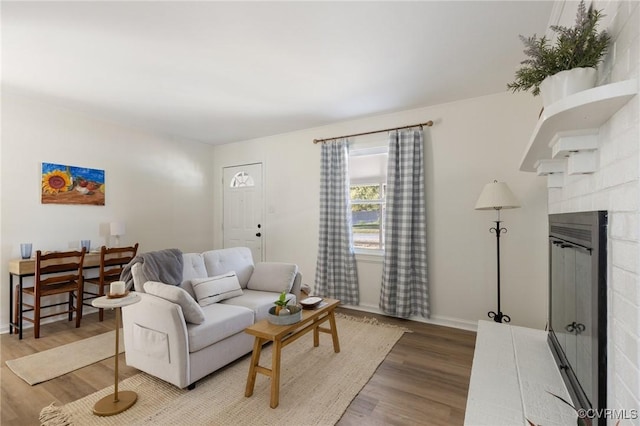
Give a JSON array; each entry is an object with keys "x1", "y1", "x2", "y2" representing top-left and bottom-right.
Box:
[{"x1": 40, "y1": 314, "x2": 406, "y2": 426}]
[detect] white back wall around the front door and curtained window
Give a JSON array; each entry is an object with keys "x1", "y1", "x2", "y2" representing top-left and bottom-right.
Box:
[{"x1": 214, "y1": 93, "x2": 547, "y2": 328}]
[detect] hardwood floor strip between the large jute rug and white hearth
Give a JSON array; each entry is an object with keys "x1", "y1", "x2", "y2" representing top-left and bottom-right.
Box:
[{"x1": 338, "y1": 309, "x2": 476, "y2": 426}]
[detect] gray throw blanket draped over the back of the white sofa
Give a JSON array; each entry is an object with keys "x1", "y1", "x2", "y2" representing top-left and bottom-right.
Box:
[{"x1": 120, "y1": 249, "x2": 183, "y2": 289}]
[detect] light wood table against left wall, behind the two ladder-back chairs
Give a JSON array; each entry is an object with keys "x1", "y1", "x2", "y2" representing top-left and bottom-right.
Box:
[{"x1": 9, "y1": 252, "x2": 100, "y2": 339}]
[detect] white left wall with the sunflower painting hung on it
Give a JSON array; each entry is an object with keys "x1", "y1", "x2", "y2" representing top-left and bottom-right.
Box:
[{"x1": 0, "y1": 93, "x2": 213, "y2": 331}]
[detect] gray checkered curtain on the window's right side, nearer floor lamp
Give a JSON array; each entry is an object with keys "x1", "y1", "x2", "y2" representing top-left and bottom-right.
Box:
[{"x1": 380, "y1": 130, "x2": 429, "y2": 318}]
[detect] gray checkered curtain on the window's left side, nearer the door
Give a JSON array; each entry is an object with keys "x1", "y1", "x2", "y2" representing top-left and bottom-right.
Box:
[{"x1": 314, "y1": 139, "x2": 359, "y2": 305}]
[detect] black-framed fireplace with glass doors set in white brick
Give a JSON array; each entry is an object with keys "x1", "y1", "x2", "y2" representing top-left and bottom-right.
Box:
[{"x1": 548, "y1": 211, "x2": 607, "y2": 425}]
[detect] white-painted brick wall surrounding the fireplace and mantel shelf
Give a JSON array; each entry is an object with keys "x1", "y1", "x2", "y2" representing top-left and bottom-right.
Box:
[{"x1": 549, "y1": 1, "x2": 640, "y2": 425}]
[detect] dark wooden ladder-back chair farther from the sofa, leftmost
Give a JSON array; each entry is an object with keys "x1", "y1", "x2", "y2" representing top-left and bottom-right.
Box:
[{"x1": 20, "y1": 248, "x2": 85, "y2": 339}]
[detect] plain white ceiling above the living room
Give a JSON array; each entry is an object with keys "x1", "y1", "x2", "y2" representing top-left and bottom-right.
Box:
[{"x1": 1, "y1": 0, "x2": 553, "y2": 144}]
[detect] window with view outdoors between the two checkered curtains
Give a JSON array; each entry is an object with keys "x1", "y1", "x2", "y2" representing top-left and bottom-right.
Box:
[{"x1": 349, "y1": 147, "x2": 387, "y2": 251}]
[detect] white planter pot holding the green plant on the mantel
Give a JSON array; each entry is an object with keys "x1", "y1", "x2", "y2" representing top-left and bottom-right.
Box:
[{"x1": 540, "y1": 68, "x2": 596, "y2": 108}]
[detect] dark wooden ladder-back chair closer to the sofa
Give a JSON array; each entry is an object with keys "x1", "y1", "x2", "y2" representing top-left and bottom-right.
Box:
[{"x1": 82, "y1": 243, "x2": 138, "y2": 321}]
